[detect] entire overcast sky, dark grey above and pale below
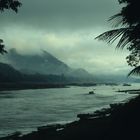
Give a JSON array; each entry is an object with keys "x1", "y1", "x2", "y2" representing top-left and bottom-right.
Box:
[{"x1": 0, "y1": 0, "x2": 130, "y2": 74}]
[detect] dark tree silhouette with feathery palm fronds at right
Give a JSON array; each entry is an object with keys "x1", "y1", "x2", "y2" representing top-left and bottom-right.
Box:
[{"x1": 96, "y1": 0, "x2": 140, "y2": 75}]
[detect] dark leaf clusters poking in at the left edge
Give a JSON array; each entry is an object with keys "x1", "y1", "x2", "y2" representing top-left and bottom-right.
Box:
[{"x1": 0, "y1": 0, "x2": 21, "y2": 54}]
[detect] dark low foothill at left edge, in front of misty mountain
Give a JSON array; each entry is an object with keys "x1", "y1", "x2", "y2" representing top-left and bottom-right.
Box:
[{"x1": 0, "y1": 63, "x2": 75, "y2": 84}]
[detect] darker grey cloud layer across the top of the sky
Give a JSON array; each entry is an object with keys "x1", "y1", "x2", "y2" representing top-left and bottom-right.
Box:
[{"x1": 1, "y1": 0, "x2": 119, "y2": 30}]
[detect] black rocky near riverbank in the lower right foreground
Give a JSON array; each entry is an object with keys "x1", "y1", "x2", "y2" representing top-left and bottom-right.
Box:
[{"x1": 1, "y1": 96, "x2": 140, "y2": 140}]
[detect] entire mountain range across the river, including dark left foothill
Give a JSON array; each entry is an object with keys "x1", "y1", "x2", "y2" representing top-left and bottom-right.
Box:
[{"x1": 0, "y1": 49, "x2": 140, "y2": 83}]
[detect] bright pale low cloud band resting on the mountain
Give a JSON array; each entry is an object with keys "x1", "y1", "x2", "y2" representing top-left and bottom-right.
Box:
[{"x1": 0, "y1": 28, "x2": 128, "y2": 74}]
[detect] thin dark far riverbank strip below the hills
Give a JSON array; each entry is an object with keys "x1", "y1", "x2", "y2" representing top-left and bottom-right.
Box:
[{"x1": 0, "y1": 82, "x2": 118, "y2": 91}]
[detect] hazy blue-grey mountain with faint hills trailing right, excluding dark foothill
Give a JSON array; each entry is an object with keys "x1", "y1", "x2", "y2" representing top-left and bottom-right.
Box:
[{"x1": 0, "y1": 49, "x2": 139, "y2": 83}]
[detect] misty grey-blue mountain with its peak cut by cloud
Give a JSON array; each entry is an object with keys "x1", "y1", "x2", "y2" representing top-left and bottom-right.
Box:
[{"x1": 6, "y1": 49, "x2": 93, "y2": 79}]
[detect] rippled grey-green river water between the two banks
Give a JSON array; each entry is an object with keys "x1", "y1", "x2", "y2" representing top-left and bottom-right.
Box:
[{"x1": 0, "y1": 84, "x2": 140, "y2": 137}]
